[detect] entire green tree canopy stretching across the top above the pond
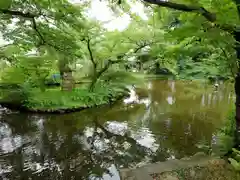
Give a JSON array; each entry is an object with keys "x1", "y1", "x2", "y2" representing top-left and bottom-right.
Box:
[{"x1": 1, "y1": 0, "x2": 238, "y2": 82}]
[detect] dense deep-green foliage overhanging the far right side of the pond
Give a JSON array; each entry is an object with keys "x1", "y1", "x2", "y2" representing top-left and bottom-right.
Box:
[{"x1": 140, "y1": 0, "x2": 238, "y2": 79}]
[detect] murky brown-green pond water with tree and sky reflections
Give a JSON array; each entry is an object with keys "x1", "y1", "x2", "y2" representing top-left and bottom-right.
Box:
[{"x1": 0, "y1": 80, "x2": 234, "y2": 180}]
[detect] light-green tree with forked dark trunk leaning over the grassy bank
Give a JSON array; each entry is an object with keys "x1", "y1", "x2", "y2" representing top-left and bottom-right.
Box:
[{"x1": 79, "y1": 21, "x2": 156, "y2": 91}]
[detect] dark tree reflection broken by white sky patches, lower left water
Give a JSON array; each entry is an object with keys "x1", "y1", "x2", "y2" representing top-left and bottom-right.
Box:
[{"x1": 0, "y1": 114, "x2": 154, "y2": 180}]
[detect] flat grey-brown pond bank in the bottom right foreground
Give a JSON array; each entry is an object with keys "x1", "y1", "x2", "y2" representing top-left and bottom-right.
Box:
[{"x1": 120, "y1": 153, "x2": 240, "y2": 180}]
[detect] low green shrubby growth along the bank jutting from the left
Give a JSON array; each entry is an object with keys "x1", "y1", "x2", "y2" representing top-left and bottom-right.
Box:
[{"x1": 0, "y1": 84, "x2": 128, "y2": 113}]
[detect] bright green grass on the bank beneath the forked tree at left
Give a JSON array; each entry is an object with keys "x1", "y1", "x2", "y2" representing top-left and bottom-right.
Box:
[{"x1": 0, "y1": 83, "x2": 126, "y2": 111}]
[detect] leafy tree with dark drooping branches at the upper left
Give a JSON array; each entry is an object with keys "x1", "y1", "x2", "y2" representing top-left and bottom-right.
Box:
[{"x1": 0, "y1": 0, "x2": 88, "y2": 89}]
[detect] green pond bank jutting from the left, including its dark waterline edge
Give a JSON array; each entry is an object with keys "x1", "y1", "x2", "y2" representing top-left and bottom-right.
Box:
[{"x1": 0, "y1": 86, "x2": 129, "y2": 114}]
